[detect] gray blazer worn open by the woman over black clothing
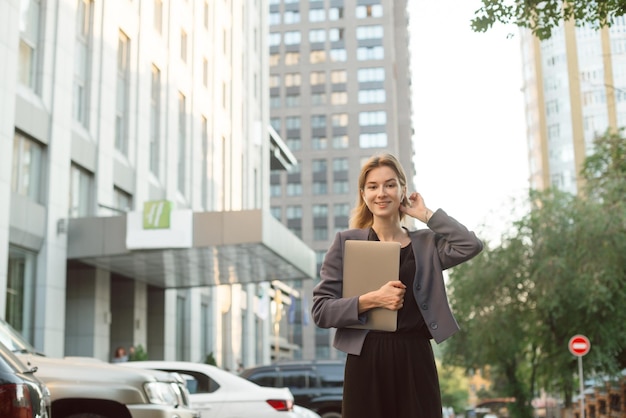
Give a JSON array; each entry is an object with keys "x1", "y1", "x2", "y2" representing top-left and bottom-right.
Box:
[{"x1": 311, "y1": 209, "x2": 483, "y2": 355}]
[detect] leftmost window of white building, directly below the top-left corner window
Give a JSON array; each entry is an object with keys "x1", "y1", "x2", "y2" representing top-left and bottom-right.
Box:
[{"x1": 11, "y1": 132, "x2": 44, "y2": 202}]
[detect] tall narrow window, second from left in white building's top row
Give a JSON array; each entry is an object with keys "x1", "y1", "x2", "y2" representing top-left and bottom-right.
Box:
[{"x1": 73, "y1": 0, "x2": 93, "y2": 127}]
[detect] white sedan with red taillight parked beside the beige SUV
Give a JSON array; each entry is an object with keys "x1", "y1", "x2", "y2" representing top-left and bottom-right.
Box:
[{"x1": 120, "y1": 361, "x2": 310, "y2": 418}]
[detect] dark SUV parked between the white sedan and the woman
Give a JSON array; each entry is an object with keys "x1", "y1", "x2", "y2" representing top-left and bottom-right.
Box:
[{"x1": 240, "y1": 360, "x2": 345, "y2": 418}]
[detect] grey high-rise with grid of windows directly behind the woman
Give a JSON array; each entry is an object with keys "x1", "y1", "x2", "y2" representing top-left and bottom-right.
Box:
[{"x1": 269, "y1": 0, "x2": 415, "y2": 358}]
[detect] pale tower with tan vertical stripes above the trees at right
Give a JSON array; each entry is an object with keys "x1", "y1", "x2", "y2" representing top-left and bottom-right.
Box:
[{"x1": 522, "y1": 16, "x2": 626, "y2": 193}]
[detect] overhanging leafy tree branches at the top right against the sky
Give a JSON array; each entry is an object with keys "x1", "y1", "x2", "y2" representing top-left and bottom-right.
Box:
[{"x1": 471, "y1": 0, "x2": 626, "y2": 39}]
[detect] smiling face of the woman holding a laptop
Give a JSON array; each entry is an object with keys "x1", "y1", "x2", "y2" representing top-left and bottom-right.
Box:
[{"x1": 361, "y1": 166, "x2": 404, "y2": 218}]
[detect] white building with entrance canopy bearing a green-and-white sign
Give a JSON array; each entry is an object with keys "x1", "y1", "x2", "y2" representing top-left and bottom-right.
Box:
[{"x1": 0, "y1": 0, "x2": 315, "y2": 370}]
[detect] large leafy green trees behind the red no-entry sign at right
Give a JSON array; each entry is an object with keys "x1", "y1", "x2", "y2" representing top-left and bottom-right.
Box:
[{"x1": 444, "y1": 131, "x2": 626, "y2": 418}]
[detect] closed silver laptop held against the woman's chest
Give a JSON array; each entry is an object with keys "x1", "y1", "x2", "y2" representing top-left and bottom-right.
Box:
[{"x1": 343, "y1": 240, "x2": 400, "y2": 331}]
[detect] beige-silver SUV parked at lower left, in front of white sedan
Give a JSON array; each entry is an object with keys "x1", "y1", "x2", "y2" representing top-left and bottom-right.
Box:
[{"x1": 0, "y1": 319, "x2": 199, "y2": 418}]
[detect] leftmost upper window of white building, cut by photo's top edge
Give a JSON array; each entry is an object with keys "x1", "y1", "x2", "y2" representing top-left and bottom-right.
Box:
[{"x1": 18, "y1": 0, "x2": 42, "y2": 90}]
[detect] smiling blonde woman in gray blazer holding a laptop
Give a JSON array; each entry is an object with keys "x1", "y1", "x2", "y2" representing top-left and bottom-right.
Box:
[{"x1": 312, "y1": 154, "x2": 482, "y2": 418}]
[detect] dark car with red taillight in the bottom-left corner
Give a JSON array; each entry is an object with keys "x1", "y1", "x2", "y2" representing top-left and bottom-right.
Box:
[{"x1": 0, "y1": 343, "x2": 51, "y2": 418}]
